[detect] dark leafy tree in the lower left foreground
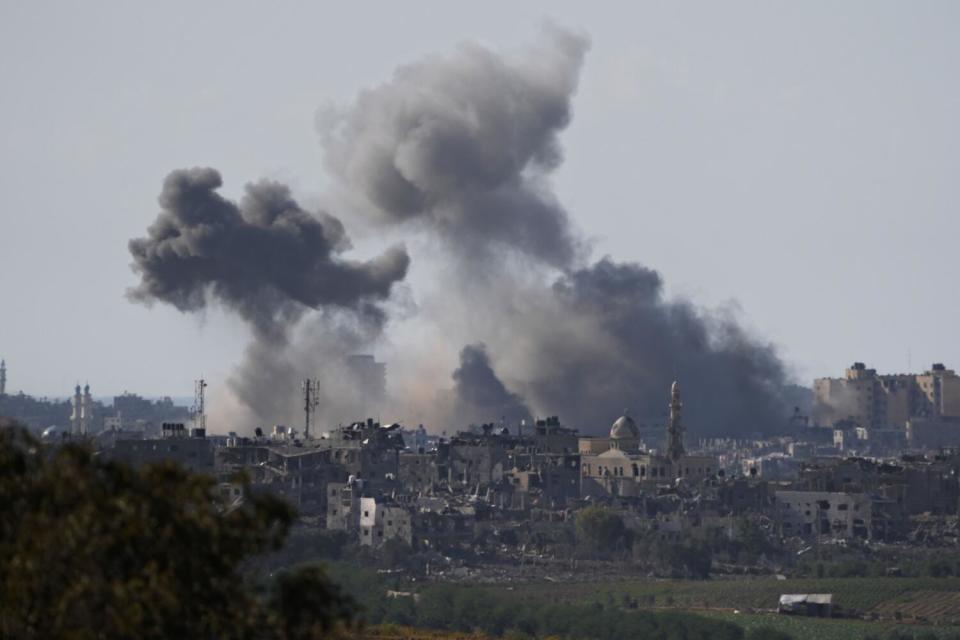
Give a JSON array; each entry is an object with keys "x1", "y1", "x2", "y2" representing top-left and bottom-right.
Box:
[{"x1": 0, "y1": 428, "x2": 351, "y2": 639}]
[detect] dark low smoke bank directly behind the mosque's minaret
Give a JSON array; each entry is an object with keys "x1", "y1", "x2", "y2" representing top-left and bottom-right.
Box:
[{"x1": 525, "y1": 258, "x2": 786, "y2": 435}]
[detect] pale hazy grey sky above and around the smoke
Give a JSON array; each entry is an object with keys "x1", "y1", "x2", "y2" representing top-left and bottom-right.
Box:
[{"x1": 0, "y1": 1, "x2": 960, "y2": 395}]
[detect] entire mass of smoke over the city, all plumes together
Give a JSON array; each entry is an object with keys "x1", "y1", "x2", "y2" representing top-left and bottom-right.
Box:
[{"x1": 131, "y1": 28, "x2": 786, "y2": 435}]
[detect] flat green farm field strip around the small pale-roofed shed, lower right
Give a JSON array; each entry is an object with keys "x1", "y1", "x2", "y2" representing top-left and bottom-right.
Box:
[{"x1": 515, "y1": 578, "x2": 960, "y2": 624}]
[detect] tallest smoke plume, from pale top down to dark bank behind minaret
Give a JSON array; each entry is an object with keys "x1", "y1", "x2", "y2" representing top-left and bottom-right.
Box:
[{"x1": 321, "y1": 29, "x2": 786, "y2": 434}]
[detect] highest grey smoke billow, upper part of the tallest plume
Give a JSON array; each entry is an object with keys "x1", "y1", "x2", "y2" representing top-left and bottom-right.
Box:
[{"x1": 319, "y1": 29, "x2": 588, "y2": 267}]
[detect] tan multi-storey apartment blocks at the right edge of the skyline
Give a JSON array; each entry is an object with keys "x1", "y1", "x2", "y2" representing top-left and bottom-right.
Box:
[{"x1": 812, "y1": 362, "x2": 960, "y2": 429}]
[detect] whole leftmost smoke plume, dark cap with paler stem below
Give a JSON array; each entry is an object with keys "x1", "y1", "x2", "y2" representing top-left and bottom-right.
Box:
[{"x1": 128, "y1": 168, "x2": 410, "y2": 431}]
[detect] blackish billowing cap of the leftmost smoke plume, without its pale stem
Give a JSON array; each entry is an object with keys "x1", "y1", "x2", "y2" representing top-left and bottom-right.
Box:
[{"x1": 129, "y1": 168, "x2": 409, "y2": 339}]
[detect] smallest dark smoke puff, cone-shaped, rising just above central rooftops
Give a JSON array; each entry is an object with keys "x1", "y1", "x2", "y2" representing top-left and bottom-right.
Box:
[{"x1": 453, "y1": 343, "x2": 530, "y2": 424}]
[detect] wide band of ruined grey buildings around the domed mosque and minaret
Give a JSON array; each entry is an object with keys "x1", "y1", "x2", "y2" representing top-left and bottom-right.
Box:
[{"x1": 82, "y1": 383, "x2": 960, "y2": 548}]
